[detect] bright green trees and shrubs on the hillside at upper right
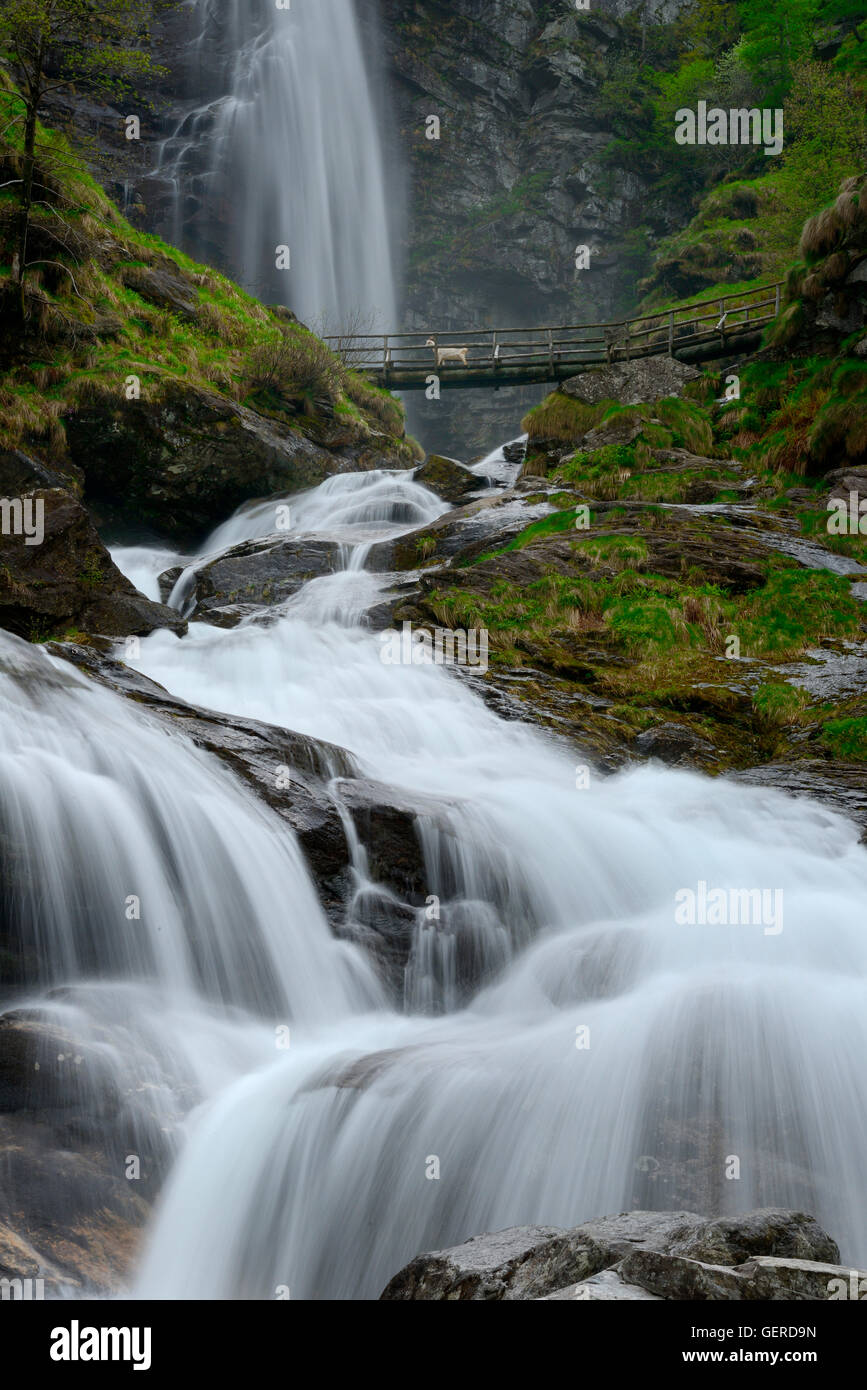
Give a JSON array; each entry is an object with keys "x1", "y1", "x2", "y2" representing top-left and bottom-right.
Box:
[{"x1": 600, "y1": 0, "x2": 867, "y2": 307}]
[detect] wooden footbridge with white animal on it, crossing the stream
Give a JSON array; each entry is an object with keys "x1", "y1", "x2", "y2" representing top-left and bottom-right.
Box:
[{"x1": 325, "y1": 282, "x2": 782, "y2": 391}]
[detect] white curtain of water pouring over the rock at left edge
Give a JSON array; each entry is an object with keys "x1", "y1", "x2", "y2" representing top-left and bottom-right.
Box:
[{"x1": 0, "y1": 634, "x2": 382, "y2": 1273}]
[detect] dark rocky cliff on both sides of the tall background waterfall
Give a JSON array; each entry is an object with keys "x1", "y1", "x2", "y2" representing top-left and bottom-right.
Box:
[{"x1": 44, "y1": 0, "x2": 697, "y2": 456}]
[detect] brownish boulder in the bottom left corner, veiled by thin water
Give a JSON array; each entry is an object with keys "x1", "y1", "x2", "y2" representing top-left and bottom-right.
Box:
[{"x1": 0, "y1": 1006, "x2": 174, "y2": 1298}]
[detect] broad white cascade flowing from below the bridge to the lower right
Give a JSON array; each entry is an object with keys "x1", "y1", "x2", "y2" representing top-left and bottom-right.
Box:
[{"x1": 67, "y1": 461, "x2": 867, "y2": 1298}]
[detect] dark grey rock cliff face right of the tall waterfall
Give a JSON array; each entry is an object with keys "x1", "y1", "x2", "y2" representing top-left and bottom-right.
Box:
[{"x1": 383, "y1": 0, "x2": 691, "y2": 453}]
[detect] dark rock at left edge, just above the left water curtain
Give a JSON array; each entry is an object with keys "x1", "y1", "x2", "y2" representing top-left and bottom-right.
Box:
[{"x1": 0, "y1": 488, "x2": 186, "y2": 641}]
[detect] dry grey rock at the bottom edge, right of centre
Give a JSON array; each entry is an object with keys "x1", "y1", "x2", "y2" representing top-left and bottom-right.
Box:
[{"x1": 381, "y1": 1208, "x2": 839, "y2": 1301}]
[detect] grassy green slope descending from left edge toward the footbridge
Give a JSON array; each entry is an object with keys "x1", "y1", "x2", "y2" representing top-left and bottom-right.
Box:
[{"x1": 0, "y1": 79, "x2": 418, "y2": 463}]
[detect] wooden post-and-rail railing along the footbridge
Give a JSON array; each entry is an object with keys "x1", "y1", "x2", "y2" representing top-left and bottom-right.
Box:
[{"x1": 325, "y1": 282, "x2": 782, "y2": 377}]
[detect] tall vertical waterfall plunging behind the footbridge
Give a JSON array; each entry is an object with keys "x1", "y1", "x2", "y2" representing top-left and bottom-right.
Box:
[{"x1": 160, "y1": 0, "x2": 399, "y2": 332}]
